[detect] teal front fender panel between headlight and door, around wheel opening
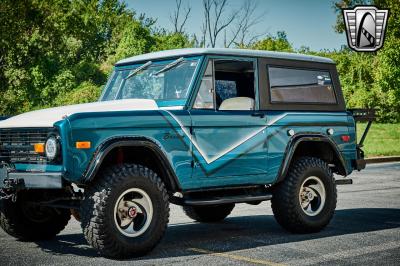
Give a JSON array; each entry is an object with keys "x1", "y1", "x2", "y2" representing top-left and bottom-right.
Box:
[{"x1": 61, "y1": 110, "x2": 192, "y2": 187}]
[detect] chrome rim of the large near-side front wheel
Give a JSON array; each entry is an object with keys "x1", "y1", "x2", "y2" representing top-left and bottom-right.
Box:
[{"x1": 114, "y1": 188, "x2": 153, "y2": 237}]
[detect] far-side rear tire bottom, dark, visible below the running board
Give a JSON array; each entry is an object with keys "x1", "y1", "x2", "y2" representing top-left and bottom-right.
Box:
[{"x1": 183, "y1": 203, "x2": 235, "y2": 223}]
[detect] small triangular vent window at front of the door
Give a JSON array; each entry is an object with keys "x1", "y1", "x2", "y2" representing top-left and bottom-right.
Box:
[{"x1": 193, "y1": 60, "x2": 214, "y2": 109}]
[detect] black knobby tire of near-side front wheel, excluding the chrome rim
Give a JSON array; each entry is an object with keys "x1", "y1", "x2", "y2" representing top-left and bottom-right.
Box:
[{"x1": 81, "y1": 164, "x2": 169, "y2": 259}]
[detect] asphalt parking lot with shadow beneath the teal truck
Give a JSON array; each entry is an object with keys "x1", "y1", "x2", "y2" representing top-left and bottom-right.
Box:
[{"x1": 0, "y1": 163, "x2": 400, "y2": 265}]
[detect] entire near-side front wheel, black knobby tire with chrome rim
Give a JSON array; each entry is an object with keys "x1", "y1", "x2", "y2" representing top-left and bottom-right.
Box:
[{"x1": 81, "y1": 164, "x2": 169, "y2": 258}]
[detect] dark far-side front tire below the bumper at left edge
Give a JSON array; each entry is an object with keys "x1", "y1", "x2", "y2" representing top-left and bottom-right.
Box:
[{"x1": 0, "y1": 197, "x2": 71, "y2": 241}]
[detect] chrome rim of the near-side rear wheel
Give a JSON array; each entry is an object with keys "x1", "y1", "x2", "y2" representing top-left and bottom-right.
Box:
[{"x1": 299, "y1": 176, "x2": 326, "y2": 216}]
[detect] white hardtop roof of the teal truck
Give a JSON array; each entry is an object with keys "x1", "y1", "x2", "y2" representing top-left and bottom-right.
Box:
[{"x1": 116, "y1": 48, "x2": 335, "y2": 65}]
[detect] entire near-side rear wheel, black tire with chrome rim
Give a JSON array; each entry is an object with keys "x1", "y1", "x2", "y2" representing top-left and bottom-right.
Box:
[{"x1": 271, "y1": 157, "x2": 337, "y2": 233}]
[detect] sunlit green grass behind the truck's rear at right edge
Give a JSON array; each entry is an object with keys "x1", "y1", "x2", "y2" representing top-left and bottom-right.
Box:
[{"x1": 357, "y1": 123, "x2": 400, "y2": 157}]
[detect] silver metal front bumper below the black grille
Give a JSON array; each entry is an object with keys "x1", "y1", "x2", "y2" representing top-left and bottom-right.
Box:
[{"x1": 0, "y1": 167, "x2": 63, "y2": 190}]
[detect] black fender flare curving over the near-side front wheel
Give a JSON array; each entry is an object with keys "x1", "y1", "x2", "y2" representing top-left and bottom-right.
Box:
[{"x1": 82, "y1": 137, "x2": 181, "y2": 191}]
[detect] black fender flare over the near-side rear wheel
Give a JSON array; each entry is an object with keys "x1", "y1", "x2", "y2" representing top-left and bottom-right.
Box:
[{"x1": 276, "y1": 133, "x2": 348, "y2": 183}]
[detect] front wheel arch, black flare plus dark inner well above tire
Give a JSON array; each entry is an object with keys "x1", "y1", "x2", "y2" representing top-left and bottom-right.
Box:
[{"x1": 83, "y1": 137, "x2": 181, "y2": 192}]
